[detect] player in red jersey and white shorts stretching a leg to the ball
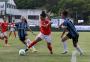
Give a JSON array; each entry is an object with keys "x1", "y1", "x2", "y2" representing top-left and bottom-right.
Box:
[{"x1": 25, "y1": 11, "x2": 53, "y2": 54}]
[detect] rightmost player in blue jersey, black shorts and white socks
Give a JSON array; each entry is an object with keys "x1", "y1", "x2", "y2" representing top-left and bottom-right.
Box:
[{"x1": 59, "y1": 11, "x2": 83, "y2": 55}]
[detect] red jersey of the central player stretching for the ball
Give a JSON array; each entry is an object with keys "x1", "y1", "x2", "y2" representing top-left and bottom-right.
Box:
[{"x1": 40, "y1": 19, "x2": 51, "y2": 35}]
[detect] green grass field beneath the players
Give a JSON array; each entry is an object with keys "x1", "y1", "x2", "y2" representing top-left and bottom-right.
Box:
[{"x1": 0, "y1": 32, "x2": 90, "y2": 62}]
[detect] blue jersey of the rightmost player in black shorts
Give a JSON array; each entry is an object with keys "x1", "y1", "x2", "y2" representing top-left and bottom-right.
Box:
[{"x1": 63, "y1": 19, "x2": 78, "y2": 37}]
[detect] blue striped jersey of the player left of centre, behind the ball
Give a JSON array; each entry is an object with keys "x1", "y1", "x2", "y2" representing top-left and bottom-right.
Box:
[{"x1": 15, "y1": 22, "x2": 29, "y2": 37}]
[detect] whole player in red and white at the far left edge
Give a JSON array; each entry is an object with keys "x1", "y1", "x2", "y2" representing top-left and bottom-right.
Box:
[{"x1": 1, "y1": 19, "x2": 9, "y2": 46}]
